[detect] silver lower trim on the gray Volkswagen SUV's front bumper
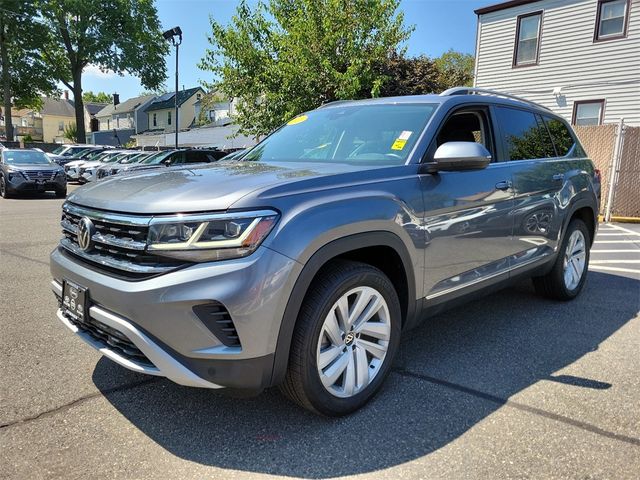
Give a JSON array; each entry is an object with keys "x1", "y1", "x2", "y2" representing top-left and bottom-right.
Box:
[{"x1": 51, "y1": 280, "x2": 223, "y2": 388}]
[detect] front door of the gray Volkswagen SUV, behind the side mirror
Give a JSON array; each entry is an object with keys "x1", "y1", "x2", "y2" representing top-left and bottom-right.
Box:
[{"x1": 422, "y1": 106, "x2": 513, "y2": 303}]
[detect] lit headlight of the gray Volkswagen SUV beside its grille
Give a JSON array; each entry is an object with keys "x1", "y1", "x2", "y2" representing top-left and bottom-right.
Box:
[{"x1": 147, "y1": 210, "x2": 278, "y2": 262}]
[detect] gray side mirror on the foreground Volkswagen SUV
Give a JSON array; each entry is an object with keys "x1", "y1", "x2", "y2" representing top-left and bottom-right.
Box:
[{"x1": 424, "y1": 142, "x2": 491, "y2": 173}]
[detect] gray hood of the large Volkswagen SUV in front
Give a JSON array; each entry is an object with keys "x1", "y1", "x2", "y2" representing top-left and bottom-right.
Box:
[{"x1": 68, "y1": 162, "x2": 363, "y2": 214}]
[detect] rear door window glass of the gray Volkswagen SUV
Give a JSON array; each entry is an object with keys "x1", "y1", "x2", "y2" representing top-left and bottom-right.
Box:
[{"x1": 496, "y1": 107, "x2": 555, "y2": 160}]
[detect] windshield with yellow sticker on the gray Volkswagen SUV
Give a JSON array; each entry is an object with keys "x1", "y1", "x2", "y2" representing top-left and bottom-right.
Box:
[{"x1": 242, "y1": 104, "x2": 436, "y2": 165}]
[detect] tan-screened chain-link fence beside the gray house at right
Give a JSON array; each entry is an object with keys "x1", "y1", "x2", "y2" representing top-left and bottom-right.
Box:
[{"x1": 574, "y1": 123, "x2": 640, "y2": 218}]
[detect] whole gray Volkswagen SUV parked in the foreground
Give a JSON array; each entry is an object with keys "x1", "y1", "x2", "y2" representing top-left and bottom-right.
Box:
[{"x1": 51, "y1": 88, "x2": 600, "y2": 415}]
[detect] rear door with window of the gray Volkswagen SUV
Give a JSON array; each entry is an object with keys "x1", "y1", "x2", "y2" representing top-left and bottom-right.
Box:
[{"x1": 495, "y1": 106, "x2": 566, "y2": 273}]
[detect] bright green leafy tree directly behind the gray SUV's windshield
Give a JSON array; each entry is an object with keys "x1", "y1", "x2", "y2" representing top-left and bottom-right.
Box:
[{"x1": 199, "y1": 0, "x2": 412, "y2": 136}]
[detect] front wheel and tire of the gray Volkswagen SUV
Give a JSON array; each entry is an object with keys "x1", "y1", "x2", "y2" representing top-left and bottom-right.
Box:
[{"x1": 281, "y1": 260, "x2": 402, "y2": 416}]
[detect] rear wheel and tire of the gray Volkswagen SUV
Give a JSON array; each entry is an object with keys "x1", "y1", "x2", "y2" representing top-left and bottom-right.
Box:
[{"x1": 533, "y1": 218, "x2": 591, "y2": 300}]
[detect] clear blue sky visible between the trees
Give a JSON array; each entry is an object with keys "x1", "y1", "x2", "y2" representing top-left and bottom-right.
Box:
[{"x1": 82, "y1": 0, "x2": 490, "y2": 101}]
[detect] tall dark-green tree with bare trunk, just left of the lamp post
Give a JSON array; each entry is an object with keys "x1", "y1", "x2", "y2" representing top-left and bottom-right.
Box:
[{"x1": 38, "y1": 0, "x2": 169, "y2": 143}]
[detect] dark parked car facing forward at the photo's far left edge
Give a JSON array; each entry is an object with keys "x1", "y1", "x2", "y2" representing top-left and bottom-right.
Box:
[{"x1": 0, "y1": 148, "x2": 67, "y2": 198}]
